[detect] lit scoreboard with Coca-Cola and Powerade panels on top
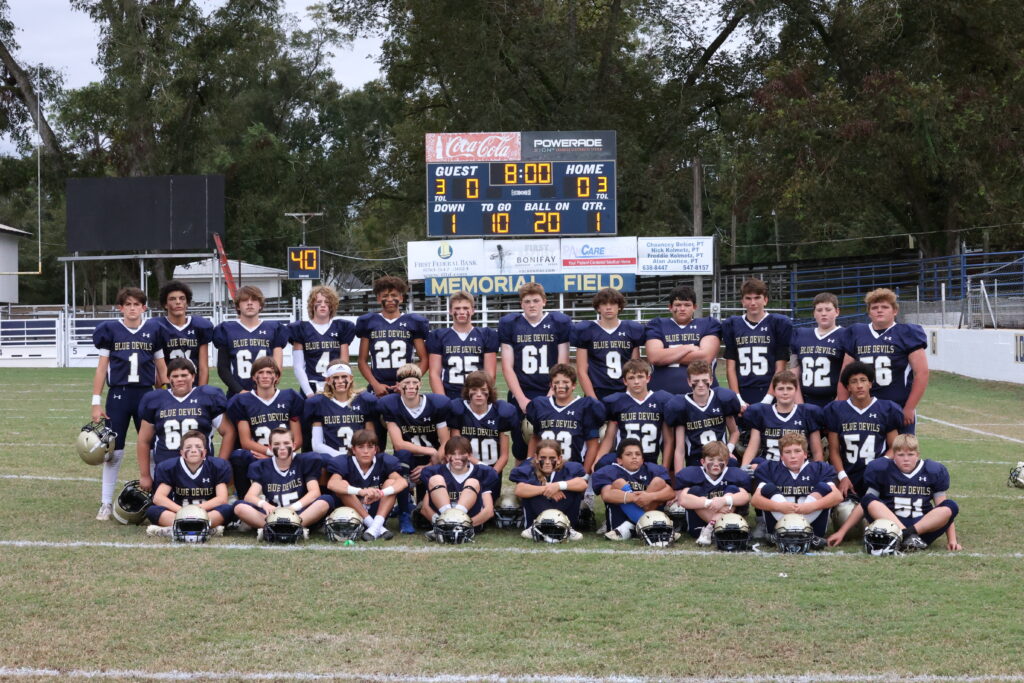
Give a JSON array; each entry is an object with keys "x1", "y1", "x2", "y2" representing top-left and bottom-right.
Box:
[{"x1": 426, "y1": 131, "x2": 617, "y2": 239}]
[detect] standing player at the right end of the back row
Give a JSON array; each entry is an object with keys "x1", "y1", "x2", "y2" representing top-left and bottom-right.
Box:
[{"x1": 850, "y1": 289, "x2": 928, "y2": 434}]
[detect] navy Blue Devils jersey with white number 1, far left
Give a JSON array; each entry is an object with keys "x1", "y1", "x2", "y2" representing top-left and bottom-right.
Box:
[{"x1": 92, "y1": 317, "x2": 164, "y2": 387}]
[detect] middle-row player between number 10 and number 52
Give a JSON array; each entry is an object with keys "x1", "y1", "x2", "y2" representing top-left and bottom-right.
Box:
[{"x1": 526, "y1": 362, "x2": 605, "y2": 463}]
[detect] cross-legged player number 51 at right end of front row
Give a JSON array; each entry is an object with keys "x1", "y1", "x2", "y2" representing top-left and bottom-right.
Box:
[{"x1": 860, "y1": 434, "x2": 963, "y2": 551}]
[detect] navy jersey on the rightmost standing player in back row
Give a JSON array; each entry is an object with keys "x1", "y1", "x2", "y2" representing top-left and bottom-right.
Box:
[{"x1": 850, "y1": 323, "x2": 928, "y2": 407}]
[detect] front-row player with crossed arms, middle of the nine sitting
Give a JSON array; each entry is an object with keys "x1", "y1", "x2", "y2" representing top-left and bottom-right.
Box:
[{"x1": 509, "y1": 438, "x2": 587, "y2": 541}]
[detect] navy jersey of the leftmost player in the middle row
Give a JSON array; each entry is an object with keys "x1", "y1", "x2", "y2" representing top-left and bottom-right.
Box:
[{"x1": 139, "y1": 386, "x2": 227, "y2": 465}]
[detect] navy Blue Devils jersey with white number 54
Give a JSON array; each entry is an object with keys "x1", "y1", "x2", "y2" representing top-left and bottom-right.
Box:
[{"x1": 822, "y1": 398, "x2": 903, "y2": 476}]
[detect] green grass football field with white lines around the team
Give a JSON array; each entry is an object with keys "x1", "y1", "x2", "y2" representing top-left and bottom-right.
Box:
[{"x1": 0, "y1": 370, "x2": 1024, "y2": 682}]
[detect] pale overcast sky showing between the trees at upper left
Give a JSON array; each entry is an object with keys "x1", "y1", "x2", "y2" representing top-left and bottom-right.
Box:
[{"x1": 0, "y1": 0, "x2": 380, "y2": 154}]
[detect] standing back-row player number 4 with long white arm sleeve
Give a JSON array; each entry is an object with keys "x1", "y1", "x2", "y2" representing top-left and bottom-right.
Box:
[{"x1": 288, "y1": 285, "x2": 355, "y2": 398}]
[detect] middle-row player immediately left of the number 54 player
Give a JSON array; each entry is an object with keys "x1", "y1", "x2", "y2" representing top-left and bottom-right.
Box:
[{"x1": 742, "y1": 370, "x2": 824, "y2": 467}]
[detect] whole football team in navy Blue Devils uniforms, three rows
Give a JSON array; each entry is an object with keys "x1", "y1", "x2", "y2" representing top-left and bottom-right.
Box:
[{"x1": 78, "y1": 276, "x2": 961, "y2": 555}]
